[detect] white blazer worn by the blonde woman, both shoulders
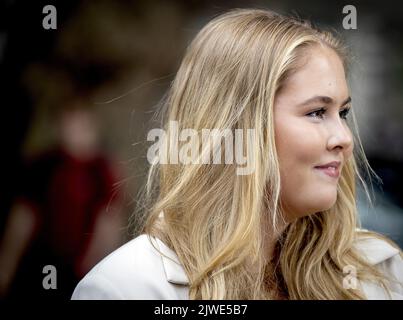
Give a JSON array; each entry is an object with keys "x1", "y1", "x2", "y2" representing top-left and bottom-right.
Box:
[{"x1": 72, "y1": 234, "x2": 403, "y2": 300}]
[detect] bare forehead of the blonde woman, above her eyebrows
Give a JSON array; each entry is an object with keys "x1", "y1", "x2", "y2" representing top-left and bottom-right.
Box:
[{"x1": 278, "y1": 46, "x2": 349, "y2": 102}]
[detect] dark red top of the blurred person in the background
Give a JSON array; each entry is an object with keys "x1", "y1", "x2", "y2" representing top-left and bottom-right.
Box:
[{"x1": 22, "y1": 150, "x2": 115, "y2": 276}]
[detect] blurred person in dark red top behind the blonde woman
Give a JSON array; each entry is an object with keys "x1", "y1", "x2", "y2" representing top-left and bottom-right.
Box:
[{"x1": 0, "y1": 98, "x2": 121, "y2": 299}]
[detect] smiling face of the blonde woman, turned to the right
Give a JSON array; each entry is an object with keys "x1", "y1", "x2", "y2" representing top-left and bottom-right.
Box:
[{"x1": 274, "y1": 46, "x2": 353, "y2": 221}]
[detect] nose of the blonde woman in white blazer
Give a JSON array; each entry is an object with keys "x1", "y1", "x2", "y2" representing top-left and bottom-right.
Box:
[{"x1": 327, "y1": 118, "x2": 353, "y2": 152}]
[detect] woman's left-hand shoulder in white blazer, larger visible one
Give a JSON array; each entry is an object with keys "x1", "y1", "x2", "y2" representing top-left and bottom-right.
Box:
[{"x1": 72, "y1": 234, "x2": 186, "y2": 300}]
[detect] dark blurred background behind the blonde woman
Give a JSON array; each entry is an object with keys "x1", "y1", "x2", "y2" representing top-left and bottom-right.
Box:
[{"x1": 0, "y1": 0, "x2": 403, "y2": 299}]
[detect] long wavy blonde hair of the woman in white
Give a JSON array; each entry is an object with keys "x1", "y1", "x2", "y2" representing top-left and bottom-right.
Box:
[{"x1": 136, "y1": 9, "x2": 400, "y2": 299}]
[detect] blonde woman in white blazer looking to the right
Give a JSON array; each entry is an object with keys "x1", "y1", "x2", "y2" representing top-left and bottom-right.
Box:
[{"x1": 73, "y1": 9, "x2": 403, "y2": 299}]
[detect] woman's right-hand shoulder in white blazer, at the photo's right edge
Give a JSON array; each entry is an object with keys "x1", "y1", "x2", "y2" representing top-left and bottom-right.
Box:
[{"x1": 355, "y1": 230, "x2": 403, "y2": 299}]
